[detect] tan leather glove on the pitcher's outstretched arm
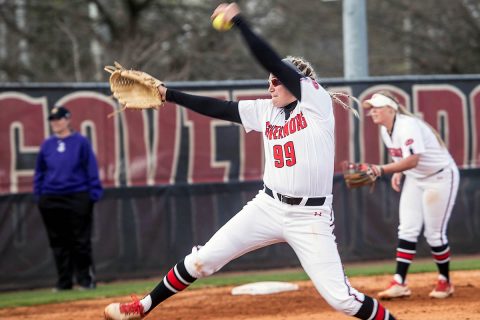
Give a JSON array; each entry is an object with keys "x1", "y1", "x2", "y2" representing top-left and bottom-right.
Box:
[{"x1": 104, "y1": 62, "x2": 165, "y2": 115}]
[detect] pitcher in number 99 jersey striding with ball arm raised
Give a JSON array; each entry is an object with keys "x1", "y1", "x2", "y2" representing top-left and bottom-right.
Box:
[{"x1": 104, "y1": 3, "x2": 394, "y2": 320}]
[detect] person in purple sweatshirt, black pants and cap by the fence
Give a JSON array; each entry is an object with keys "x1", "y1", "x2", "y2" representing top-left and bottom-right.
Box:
[{"x1": 34, "y1": 106, "x2": 103, "y2": 291}]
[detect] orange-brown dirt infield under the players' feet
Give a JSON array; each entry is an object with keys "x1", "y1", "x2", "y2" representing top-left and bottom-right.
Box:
[{"x1": 0, "y1": 270, "x2": 480, "y2": 320}]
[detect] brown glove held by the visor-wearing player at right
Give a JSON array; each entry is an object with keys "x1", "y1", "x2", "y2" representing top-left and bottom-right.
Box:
[{"x1": 342, "y1": 161, "x2": 383, "y2": 189}]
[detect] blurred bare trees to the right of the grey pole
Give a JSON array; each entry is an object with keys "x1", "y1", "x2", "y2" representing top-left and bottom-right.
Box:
[{"x1": 369, "y1": 0, "x2": 480, "y2": 75}]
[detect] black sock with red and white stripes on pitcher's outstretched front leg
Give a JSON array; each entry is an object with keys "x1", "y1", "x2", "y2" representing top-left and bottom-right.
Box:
[{"x1": 146, "y1": 261, "x2": 197, "y2": 312}]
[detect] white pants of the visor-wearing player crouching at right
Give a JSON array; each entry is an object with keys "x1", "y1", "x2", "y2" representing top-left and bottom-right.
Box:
[{"x1": 398, "y1": 164, "x2": 460, "y2": 247}]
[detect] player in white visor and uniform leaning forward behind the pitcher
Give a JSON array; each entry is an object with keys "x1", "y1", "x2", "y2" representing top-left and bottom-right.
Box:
[{"x1": 363, "y1": 91, "x2": 460, "y2": 299}]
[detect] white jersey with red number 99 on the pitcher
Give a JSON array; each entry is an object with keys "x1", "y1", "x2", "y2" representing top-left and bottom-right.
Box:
[{"x1": 239, "y1": 78, "x2": 335, "y2": 197}]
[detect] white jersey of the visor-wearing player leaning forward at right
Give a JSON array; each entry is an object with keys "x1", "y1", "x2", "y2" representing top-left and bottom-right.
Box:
[{"x1": 380, "y1": 114, "x2": 453, "y2": 178}]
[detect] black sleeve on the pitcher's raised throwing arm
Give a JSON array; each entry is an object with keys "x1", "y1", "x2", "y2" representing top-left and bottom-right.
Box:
[{"x1": 233, "y1": 15, "x2": 303, "y2": 100}]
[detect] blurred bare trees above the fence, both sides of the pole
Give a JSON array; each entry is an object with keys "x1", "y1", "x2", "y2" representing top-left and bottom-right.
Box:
[{"x1": 0, "y1": 0, "x2": 480, "y2": 82}]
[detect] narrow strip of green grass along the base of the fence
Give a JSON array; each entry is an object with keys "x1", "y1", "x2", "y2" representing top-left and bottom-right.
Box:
[{"x1": 0, "y1": 258, "x2": 480, "y2": 308}]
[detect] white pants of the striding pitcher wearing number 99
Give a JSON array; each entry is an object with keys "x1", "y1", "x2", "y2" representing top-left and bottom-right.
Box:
[{"x1": 185, "y1": 191, "x2": 364, "y2": 315}]
